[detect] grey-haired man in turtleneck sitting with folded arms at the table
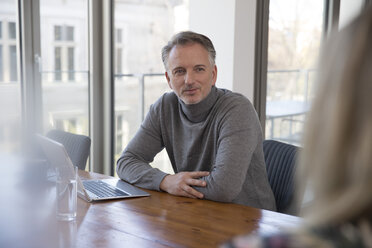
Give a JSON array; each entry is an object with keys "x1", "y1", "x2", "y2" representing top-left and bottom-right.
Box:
[{"x1": 117, "y1": 32, "x2": 276, "y2": 210}]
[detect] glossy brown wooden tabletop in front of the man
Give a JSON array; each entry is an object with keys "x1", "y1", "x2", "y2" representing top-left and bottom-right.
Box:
[{"x1": 60, "y1": 171, "x2": 300, "y2": 248}]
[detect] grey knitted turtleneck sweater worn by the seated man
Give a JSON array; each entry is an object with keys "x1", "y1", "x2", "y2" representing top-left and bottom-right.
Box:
[{"x1": 117, "y1": 86, "x2": 276, "y2": 210}]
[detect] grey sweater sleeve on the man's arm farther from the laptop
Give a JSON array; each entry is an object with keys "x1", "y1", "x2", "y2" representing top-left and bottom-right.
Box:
[{"x1": 195, "y1": 96, "x2": 262, "y2": 202}]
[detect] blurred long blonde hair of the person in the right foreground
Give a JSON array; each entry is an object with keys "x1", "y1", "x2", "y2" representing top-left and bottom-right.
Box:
[{"x1": 299, "y1": 8, "x2": 372, "y2": 225}]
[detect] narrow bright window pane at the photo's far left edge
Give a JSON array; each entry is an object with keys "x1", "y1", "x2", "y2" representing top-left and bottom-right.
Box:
[{"x1": 0, "y1": 0, "x2": 22, "y2": 153}]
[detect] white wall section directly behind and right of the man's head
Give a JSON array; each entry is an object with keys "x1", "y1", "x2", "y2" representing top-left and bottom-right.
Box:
[{"x1": 189, "y1": 0, "x2": 256, "y2": 101}]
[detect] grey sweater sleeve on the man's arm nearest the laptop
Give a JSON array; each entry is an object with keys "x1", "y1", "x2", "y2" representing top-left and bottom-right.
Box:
[{"x1": 116, "y1": 99, "x2": 167, "y2": 190}]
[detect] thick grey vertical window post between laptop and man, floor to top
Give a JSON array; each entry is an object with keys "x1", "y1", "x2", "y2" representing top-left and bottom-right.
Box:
[{"x1": 89, "y1": 0, "x2": 114, "y2": 175}]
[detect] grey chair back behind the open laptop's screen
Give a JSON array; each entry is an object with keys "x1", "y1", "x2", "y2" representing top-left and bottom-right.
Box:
[{"x1": 46, "y1": 129, "x2": 91, "y2": 170}]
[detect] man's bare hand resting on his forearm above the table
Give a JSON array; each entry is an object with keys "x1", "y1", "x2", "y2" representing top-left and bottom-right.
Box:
[{"x1": 160, "y1": 171, "x2": 209, "y2": 199}]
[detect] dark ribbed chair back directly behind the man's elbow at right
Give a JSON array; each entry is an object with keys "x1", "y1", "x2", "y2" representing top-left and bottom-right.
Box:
[{"x1": 263, "y1": 140, "x2": 299, "y2": 215}]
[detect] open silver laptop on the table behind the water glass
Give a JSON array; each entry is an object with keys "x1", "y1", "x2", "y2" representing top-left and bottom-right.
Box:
[{"x1": 36, "y1": 134, "x2": 150, "y2": 202}]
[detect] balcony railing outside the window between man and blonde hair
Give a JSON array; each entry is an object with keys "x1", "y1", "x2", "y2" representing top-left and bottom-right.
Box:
[{"x1": 266, "y1": 69, "x2": 316, "y2": 145}]
